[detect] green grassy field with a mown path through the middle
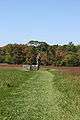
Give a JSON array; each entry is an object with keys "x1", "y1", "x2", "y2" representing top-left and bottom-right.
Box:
[{"x1": 0, "y1": 68, "x2": 80, "y2": 120}]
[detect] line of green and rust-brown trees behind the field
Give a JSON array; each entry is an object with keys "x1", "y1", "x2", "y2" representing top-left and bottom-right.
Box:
[{"x1": 0, "y1": 41, "x2": 80, "y2": 66}]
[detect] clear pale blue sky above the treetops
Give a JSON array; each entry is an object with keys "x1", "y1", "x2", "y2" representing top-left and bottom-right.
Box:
[{"x1": 0, "y1": 0, "x2": 80, "y2": 46}]
